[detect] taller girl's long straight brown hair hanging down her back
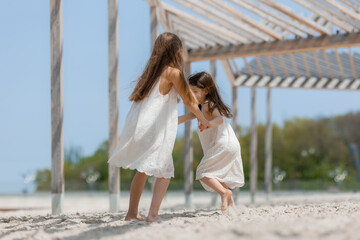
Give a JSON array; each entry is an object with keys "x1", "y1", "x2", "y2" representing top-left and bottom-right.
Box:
[{"x1": 129, "y1": 32, "x2": 183, "y2": 102}]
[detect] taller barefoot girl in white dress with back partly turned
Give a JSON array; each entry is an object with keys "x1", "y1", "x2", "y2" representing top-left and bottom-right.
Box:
[{"x1": 108, "y1": 32, "x2": 209, "y2": 222}]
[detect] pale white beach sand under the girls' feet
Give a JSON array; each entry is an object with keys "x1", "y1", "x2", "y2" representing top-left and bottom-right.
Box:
[{"x1": 0, "y1": 192, "x2": 360, "y2": 240}]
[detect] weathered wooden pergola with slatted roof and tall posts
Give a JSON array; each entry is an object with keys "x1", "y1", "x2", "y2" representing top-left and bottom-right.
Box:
[{"x1": 50, "y1": 0, "x2": 360, "y2": 213}]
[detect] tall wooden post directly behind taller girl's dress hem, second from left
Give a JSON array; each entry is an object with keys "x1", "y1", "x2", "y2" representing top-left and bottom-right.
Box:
[{"x1": 108, "y1": 0, "x2": 120, "y2": 213}]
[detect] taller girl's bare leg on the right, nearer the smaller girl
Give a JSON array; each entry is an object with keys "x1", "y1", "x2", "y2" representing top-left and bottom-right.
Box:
[{"x1": 146, "y1": 178, "x2": 170, "y2": 222}]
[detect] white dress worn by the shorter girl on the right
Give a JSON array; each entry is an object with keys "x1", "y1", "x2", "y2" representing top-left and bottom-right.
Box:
[{"x1": 196, "y1": 116, "x2": 245, "y2": 192}]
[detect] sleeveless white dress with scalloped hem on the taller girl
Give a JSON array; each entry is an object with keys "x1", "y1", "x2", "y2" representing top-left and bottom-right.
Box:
[{"x1": 108, "y1": 74, "x2": 178, "y2": 178}]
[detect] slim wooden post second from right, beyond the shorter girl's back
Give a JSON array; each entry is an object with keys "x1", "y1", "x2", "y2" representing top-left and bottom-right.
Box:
[{"x1": 250, "y1": 87, "x2": 257, "y2": 203}]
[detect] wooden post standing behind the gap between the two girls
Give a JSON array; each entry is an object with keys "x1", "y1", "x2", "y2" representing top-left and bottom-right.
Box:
[{"x1": 184, "y1": 62, "x2": 193, "y2": 208}]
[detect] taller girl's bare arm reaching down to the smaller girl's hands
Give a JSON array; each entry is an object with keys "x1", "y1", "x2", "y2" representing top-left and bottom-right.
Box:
[{"x1": 164, "y1": 67, "x2": 209, "y2": 127}]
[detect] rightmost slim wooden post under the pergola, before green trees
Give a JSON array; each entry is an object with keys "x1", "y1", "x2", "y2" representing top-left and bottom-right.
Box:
[{"x1": 265, "y1": 88, "x2": 272, "y2": 200}]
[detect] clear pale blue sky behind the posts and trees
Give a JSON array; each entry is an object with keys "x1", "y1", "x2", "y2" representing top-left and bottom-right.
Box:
[{"x1": 0, "y1": 0, "x2": 360, "y2": 194}]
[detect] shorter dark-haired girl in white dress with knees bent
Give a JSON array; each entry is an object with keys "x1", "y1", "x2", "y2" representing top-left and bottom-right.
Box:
[{"x1": 178, "y1": 72, "x2": 244, "y2": 211}]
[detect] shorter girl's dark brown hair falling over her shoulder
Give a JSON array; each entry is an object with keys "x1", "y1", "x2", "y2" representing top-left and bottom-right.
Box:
[{"x1": 189, "y1": 72, "x2": 232, "y2": 118}]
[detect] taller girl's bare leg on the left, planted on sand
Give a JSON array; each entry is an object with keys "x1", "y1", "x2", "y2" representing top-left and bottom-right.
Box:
[{"x1": 125, "y1": 172, "x2": 148, "y2": 221}]
